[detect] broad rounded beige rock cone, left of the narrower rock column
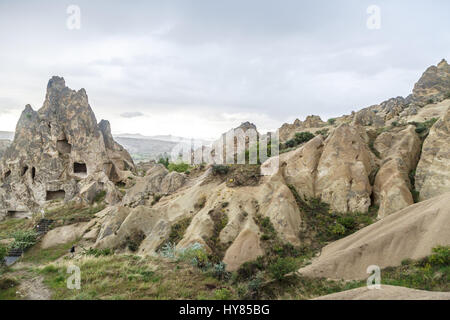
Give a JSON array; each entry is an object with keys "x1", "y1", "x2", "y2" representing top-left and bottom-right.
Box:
[{"x1": 315, "y1": 124, "x2": 375, "y2": 212}]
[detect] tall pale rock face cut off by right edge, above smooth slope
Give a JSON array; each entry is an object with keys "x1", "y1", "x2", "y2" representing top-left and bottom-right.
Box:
[{"x1": 416, "y1": 108, "x2": 450, "y2": 200}]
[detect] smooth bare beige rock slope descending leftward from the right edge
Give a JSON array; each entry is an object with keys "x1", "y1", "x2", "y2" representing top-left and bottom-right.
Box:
[{"x1": 299, "y1": 193, "x2": 450, "y2": 280}]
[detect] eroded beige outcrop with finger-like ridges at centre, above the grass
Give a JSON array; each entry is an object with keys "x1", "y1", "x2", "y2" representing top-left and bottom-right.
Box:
[{"x1": 95, "y1": 168, "x2": 301, "y2": 270}]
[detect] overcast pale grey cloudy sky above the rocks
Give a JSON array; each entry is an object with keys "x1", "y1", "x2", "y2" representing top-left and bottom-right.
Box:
[{"x1": 0, "y1": 0, "x2": 450, "y2": 138}]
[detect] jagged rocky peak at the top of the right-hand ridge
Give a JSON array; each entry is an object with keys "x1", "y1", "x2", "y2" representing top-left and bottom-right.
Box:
[{"x1": 413, "y1": 59, "x2": 450, "y2": 101}]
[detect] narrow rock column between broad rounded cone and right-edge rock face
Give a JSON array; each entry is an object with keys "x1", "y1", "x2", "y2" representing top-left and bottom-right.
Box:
[{"x1": 374, "y1": 126, "x2": 421, "y2": 218}]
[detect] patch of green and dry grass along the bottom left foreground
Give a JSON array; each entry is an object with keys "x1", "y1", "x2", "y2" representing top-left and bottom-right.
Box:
[{"x1": 38, "y1": 255, "x2": 224, "y2": 300}]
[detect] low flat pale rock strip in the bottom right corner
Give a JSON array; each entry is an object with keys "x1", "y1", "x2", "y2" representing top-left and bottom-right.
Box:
[{"x1": 314, "y1": 284, "x2": 450, "y2": 300}]
